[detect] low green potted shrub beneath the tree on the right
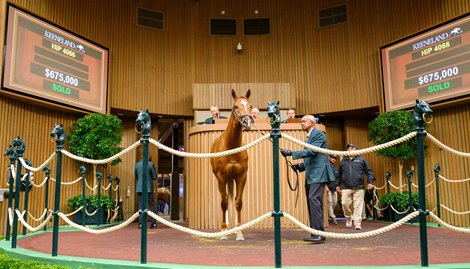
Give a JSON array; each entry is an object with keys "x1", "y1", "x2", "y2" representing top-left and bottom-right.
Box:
[{"x1": 380, "y1": 191, "x2": 418, "y2": 222}]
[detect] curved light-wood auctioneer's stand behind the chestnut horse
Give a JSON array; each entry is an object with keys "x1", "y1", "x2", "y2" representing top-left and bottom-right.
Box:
[{"x1": 187, "y1": 123, "x2": 328, "y2": 229}]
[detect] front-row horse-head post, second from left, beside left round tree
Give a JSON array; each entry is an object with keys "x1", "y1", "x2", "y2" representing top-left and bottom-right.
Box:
[{"x1": 51, "y1": 124, "x2": 66, "y2": 257}]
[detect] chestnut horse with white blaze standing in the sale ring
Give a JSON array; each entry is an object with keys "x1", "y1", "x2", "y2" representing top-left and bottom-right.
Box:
[{"x1": 211, "y1": 90, "x2": 253, "y2": 240}]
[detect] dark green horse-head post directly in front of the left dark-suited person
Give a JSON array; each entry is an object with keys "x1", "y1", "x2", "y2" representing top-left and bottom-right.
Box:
[{"x1": 135, "y1": 110, "x2": 152, "y2": 264}]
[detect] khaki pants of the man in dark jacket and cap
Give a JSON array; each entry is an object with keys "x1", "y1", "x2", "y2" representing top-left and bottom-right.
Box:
[{"x1": 341, "y1": 189, "x2": 365, "y2": 225}]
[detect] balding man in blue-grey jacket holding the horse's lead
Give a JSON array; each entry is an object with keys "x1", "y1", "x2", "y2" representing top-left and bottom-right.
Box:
[{"x1": 281, "y1": 115, "x2": 335, "y2": 244}]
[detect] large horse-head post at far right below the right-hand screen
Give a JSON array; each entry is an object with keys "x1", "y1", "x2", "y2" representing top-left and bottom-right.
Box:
[{"x1": 413, "y1": 100, "x2": 432, "y2": 267}]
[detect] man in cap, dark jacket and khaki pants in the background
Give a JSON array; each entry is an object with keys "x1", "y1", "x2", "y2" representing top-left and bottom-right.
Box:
[{"x1": 335, "y1": 144, "x2": 375, "y2": 230}]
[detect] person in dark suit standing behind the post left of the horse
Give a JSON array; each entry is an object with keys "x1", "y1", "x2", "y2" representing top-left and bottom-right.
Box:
[{"x1": 134, "y1": 155, "x2": 157, "y2": 228}]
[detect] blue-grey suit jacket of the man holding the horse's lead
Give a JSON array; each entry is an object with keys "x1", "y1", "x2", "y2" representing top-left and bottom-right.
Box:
[{"x1": 292, "y1": 128, "x2": 335, "y2": 184}]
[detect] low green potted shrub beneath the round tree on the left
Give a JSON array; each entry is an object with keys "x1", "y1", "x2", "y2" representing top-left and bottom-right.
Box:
[{"x1": 67, "y1": 194, "x2": 115, "y2": 224}]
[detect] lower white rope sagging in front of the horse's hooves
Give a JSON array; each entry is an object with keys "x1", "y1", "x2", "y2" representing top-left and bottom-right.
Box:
[{"x1": 147, "y1": 211, "x2": 272, "y2": 238}]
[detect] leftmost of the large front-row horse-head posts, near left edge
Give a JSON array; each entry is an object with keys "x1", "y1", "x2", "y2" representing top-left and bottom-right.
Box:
[{"x1": 10, "y1": 136, "x2": 26, "y2": 248}]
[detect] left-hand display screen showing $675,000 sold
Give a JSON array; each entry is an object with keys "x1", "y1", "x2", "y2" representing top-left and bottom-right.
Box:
[{"x1": 2, "y1": 5, "x2": 108, "y2": 113}]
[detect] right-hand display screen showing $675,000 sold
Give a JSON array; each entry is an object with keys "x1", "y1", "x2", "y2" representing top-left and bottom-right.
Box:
[{"x1": 380, "y1": 14, "x2": 470, "y2": 111}]
